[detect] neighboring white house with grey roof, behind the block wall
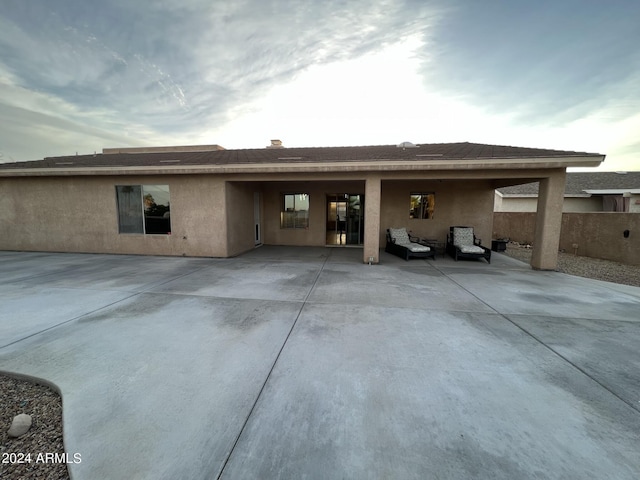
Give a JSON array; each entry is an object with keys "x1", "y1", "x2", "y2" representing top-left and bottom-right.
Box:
[{"x1": 495, "y1": 172, "x2": 640, "y2": 213}]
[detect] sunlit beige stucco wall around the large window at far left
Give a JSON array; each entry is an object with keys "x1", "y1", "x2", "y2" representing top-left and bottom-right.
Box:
[{"x1": 0, "y1": 175, "x2": 227, "y2": 257}]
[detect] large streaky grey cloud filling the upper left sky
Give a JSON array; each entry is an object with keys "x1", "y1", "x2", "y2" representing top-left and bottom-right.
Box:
[{"x1": 0, "y1": 0, "x2": 448, "y2": 161}]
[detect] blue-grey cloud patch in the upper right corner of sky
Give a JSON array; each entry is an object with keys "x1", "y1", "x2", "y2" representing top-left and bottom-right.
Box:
[{"x1": 425, "y1": 0, "x2": 640, "y2": 123}]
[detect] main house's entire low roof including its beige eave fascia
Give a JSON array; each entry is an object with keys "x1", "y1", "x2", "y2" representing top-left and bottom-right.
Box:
[{"x1": 0, "y1": 142, "x2": 604, "y2": 176}]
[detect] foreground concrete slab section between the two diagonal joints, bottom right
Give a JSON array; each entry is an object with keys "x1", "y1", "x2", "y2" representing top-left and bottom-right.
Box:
[{"x1": 222, "y1": 305, "x2": 640, "y2": 479}]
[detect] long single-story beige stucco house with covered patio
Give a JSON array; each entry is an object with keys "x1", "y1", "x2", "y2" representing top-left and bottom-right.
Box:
[{"x1": 0, "y1": 141, "x2": 604, "y2": 269}]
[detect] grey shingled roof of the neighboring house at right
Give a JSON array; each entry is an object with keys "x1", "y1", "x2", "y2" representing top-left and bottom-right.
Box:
[{"x1": 498, "y1": 172, "x2": 640, "y2": 197}]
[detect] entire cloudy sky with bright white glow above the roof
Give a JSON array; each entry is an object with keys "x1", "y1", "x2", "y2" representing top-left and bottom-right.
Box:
[{"x1": 0, "y1": 0, "x2": 640, "y2": 171}]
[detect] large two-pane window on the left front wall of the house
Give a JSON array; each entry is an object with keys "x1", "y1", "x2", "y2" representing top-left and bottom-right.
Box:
[{"x1": 116, "y1": 185, "x2": 171, "y2": 235}]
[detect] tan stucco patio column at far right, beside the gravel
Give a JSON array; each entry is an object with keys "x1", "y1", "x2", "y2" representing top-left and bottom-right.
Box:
[{"x1": 531, "y1": 169, "x2": 566, "y2": 270}]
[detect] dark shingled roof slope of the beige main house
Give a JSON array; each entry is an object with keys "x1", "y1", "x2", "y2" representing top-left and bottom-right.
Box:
[{"x1": 0, "y1": 142, "x2": 604, "y2": 174}]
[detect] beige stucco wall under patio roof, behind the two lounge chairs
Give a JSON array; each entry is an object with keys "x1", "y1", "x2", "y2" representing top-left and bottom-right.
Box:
[{"x1": 380, "y1": 180, "x2": 494, "y2": 246}]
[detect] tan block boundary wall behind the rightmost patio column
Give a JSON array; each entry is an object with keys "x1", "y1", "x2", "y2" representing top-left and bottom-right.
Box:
[{"x1": 493, "y1": 212, "x2": 640, "y2": 265}]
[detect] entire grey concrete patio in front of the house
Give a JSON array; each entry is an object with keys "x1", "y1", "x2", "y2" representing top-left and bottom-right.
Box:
[{"x1": 0, "y1": 247, "x2": 640, "y2": 480}]
